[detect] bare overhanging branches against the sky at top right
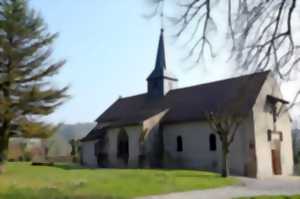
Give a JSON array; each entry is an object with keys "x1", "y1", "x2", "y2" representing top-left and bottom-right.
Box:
[{"x1": 149, "y1": 0, "x2": 300, "y2": 80}]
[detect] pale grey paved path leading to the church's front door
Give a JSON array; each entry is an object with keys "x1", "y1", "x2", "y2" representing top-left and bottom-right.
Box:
[{"x1": 138, "y1": 177, "x2": 300, "y2": 199}]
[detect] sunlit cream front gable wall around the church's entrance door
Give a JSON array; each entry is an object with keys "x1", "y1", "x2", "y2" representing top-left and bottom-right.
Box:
[{"x1": 253, "y1": 76, "x2": 294, "y2": 178}]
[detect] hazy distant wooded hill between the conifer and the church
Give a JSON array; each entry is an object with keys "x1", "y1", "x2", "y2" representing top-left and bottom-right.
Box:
[{"x1": 48, "y1": 123, "x2": 96, "y2": 157}]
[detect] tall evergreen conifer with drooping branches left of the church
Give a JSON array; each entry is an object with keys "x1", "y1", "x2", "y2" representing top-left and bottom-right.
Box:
[{"x1": 0, "y1": 0, "x2": 67, "y2": 170}]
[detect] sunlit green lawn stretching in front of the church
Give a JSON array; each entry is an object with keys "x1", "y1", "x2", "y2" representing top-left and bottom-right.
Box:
[{"x1": 0, "y1": 163, "x2": 237, "y2": 199}]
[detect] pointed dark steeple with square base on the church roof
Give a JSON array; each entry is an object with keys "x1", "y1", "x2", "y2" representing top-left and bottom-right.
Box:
[{"x1": 147, "y1": 28, "x2": 178, "y2": 97}]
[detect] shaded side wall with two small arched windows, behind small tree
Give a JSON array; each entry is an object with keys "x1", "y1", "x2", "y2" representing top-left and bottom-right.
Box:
[{"x1": 163, "y1": 117, "x2": 253, "y2": 175}]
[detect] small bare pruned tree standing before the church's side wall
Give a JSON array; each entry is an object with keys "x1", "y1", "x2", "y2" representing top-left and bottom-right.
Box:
[{"x1": 202, "y1": 75, "x2": 258, "y2": 177}]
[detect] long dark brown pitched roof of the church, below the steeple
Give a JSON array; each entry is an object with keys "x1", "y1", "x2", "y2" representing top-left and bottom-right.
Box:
[{"x1": 96, "y1": 71, "x2": 269, "y2": 126}]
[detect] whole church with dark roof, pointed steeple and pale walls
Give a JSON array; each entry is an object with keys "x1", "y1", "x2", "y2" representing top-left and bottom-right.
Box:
[{"x1": 81, "y1": 30, "x2": 294, "y2": 178}]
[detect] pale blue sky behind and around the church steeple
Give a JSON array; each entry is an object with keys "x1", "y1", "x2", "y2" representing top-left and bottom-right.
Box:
[{"x1": 30, "y1": 0, "x2": 298, "y2": 123}]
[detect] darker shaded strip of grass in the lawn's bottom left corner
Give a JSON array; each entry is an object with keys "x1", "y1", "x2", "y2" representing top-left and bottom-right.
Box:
[{"x1": 0, "y1": 188, "x2": 123, "y2": 199}]
